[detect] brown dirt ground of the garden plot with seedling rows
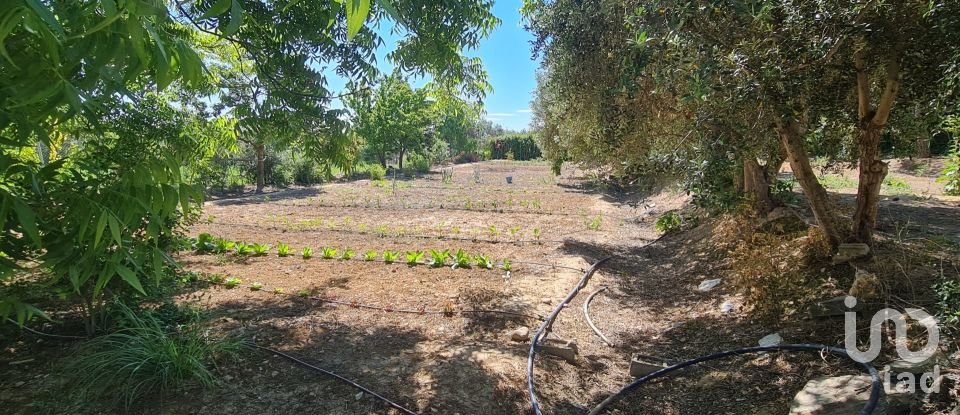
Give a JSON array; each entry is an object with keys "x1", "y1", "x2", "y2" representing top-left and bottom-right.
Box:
[{"x1": 0, "y1": 162, "x2": 960, "y2": 415}]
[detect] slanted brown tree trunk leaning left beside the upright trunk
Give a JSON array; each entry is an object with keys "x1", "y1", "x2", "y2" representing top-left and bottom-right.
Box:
[{"x1": 776, "y1": 120, "x2": 840, "y2": 248}]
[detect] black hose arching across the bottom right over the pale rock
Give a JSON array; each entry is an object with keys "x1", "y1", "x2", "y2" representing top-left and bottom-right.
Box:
[{"x1": 580, "y1": 344, "x2": 883, "y2": 415}]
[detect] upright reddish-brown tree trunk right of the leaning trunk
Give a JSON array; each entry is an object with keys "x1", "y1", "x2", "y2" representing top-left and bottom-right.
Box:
[{"x1": 853, "y1": 125, "x2": 887, "y2": 244}]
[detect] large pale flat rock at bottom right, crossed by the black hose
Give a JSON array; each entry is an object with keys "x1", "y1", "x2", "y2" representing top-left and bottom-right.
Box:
[{"x1": 789, "y1": 375, "x2": 913, "y2": 415}]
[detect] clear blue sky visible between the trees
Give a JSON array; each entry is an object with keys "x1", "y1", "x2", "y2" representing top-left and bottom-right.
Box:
[{"x1": 328, "y1": 0, "x2": 539, "y2": 130}]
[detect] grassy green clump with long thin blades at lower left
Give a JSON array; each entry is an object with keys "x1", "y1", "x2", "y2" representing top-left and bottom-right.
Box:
[{"x1": 65, "y1": 304, "x2": 240, "y2": 409}]
